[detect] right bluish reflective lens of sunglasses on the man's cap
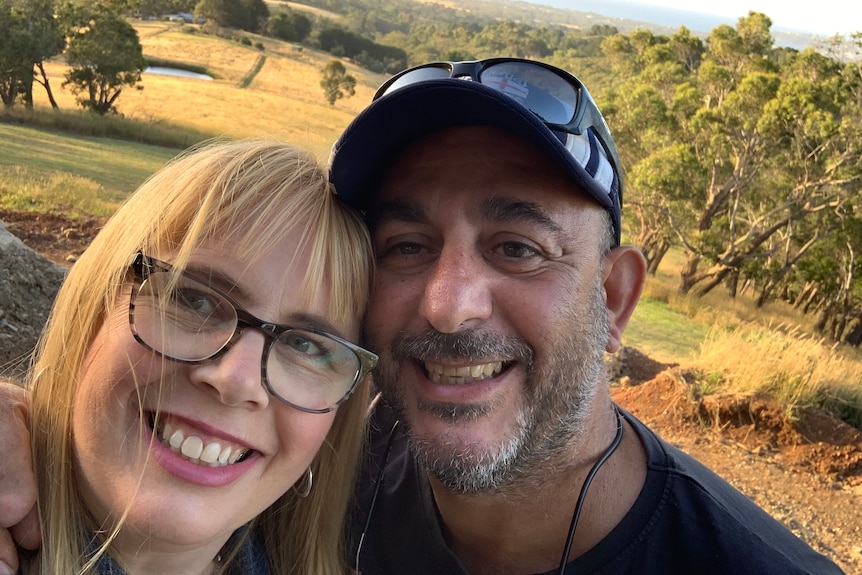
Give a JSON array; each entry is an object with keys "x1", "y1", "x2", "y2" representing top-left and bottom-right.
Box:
[{"x1": 479, "y1": 62, "x2": 578, "y2": 124}]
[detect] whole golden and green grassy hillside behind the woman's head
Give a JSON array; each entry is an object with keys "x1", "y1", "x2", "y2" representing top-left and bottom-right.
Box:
[{"x1": 0, "y1": 21, "x2": 383, "y2": 215}]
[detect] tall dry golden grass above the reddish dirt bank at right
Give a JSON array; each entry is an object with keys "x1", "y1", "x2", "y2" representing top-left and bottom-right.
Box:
[{"x1": 644, "y1": 245, "x2": 862, "y2": 425}]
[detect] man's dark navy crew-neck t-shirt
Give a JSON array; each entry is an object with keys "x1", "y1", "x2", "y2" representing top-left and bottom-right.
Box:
[{"x1": 351, "y1": 405, "x2": 842, "y2": 575}]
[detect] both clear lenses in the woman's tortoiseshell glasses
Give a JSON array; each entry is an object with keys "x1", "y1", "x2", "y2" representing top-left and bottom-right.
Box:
[{"x1": 132, "y1": 272, "x2": 361, "y2": 410}]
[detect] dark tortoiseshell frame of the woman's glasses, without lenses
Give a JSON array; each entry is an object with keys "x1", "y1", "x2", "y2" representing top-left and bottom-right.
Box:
[{"x1": 129, "y1": 252, "x2": 378, "y2": 413}]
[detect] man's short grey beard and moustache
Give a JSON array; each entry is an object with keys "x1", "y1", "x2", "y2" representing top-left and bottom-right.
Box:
[{"x1": 368, "y1": 277, "x2": 609, "y2": 494}]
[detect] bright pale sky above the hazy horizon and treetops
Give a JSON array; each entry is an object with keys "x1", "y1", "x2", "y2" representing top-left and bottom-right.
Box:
[{"x1": 527, "y1": 0, "x2": 862, "y2": 37}]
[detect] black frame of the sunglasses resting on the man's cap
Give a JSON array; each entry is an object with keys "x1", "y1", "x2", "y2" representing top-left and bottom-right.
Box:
[{"x1": 372, "y1": 58, "x2": 622, "y2": 196}]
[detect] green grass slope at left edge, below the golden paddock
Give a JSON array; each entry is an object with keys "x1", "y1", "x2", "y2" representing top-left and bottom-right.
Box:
[{"x1": 0, "y1": 124, "x2": 178, "y2": 215}]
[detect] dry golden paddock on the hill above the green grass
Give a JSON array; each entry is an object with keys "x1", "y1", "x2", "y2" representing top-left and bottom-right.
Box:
[{"x1": 34, "y1": 21, "x2": 384, "y2": 160}]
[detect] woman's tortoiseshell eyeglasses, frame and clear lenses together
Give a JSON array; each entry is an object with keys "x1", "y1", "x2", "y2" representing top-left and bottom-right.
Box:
[{"x1": 129, "y1": 253, "x2": 377, "y2": 413}]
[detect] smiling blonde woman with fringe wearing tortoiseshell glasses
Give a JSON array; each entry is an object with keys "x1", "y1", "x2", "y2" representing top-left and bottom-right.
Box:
[{"x1": 24, "y1": 141, "x2": 376, "y2": 575}]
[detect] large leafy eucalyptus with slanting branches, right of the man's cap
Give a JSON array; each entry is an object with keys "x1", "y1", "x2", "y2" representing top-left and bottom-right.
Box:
[{"x1": 602, "y1": 12, "x2": 862, "y2": 310}]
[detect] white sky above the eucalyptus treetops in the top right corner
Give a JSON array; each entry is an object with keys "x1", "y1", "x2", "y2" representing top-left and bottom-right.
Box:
[{"x1": 629, "y1": 0, "x2": 862, "y2": 36}]
